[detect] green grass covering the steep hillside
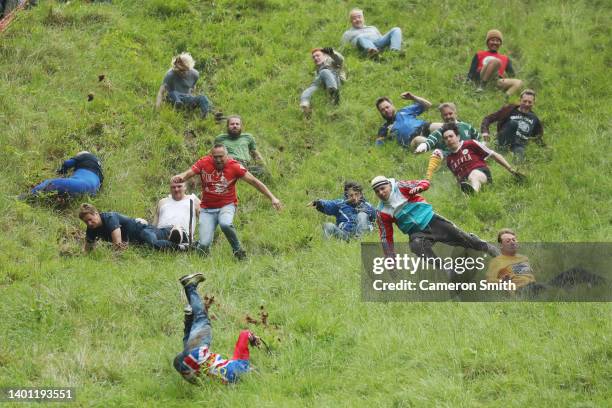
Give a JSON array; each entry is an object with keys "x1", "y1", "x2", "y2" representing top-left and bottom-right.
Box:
[{"x1": 0, "y1": 0, "x2": 612, "y2": 407}]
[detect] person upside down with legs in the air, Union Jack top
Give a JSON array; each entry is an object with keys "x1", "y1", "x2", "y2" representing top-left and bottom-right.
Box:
[{"x1": 173, "y1": 273, "x2": 261, "y2": 384}]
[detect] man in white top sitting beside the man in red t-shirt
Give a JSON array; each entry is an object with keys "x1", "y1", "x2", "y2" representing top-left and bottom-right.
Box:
[{"x1": 153, "y1": 181, "x2": 200, "y2": 242}]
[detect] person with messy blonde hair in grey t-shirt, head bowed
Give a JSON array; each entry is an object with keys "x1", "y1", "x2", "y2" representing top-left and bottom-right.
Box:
[{"x1": 155, "y1": 52, "x2": 212, "y2": 118}]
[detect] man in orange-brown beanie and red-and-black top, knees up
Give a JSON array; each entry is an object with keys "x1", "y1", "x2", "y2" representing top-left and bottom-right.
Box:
[{"x1": 467, "y1": 30, "x2": 523, "y2": 96}]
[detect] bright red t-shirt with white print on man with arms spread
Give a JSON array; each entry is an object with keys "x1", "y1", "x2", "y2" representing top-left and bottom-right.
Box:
[{"x1": 191, "y1": 156, "x2": 247, "y2": 208}]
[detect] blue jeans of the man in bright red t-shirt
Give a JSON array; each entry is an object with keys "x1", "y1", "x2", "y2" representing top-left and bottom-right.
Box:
[{"x1": 199, "y1": 204, "x2": 241, "y2": 252}]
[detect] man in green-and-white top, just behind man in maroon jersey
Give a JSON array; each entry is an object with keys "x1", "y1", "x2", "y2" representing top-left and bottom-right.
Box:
[{"x1": 414, "y1": 102, "x2": 480, "y2": 181}]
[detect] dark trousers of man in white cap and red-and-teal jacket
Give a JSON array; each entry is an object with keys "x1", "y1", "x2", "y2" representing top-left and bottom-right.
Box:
[{"x1": 410, "y1": 214, "x2": 491, "y2": 258}]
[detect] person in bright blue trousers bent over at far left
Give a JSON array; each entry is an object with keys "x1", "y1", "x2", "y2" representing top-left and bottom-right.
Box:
[{"x1": 20, "y1": 151, "x2": 104, "y2": 198}]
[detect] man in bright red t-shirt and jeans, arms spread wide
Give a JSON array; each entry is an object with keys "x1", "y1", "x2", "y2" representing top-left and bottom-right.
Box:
[{"x1": 172, "y1": 143, "x2": 282, "y2": 259}]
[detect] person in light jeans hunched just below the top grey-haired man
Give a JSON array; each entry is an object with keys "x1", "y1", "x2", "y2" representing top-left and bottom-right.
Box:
[{"x1": 300, "y1": 47, "x2": 346, "y2": 118}]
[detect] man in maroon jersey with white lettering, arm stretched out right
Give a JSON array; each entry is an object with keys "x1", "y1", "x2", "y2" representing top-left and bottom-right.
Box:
[{"x1": 440, "y1": 123, "x2": 523, "y2": 193}]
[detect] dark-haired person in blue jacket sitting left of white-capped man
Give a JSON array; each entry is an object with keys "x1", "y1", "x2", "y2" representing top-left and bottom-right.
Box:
[{"x1": 310, "y1": 182, "x2": 376, "y2": 241}]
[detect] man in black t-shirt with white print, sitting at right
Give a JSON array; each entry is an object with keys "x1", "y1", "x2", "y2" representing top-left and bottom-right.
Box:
[{"x1": 480, "y1": 89, "x2": 544, "y2": 161}]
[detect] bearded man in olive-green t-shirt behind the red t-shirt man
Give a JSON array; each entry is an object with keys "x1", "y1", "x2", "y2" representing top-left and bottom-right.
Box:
[{"x1": 215, "y1": 115, "x2": 266, "y2": 177}]
